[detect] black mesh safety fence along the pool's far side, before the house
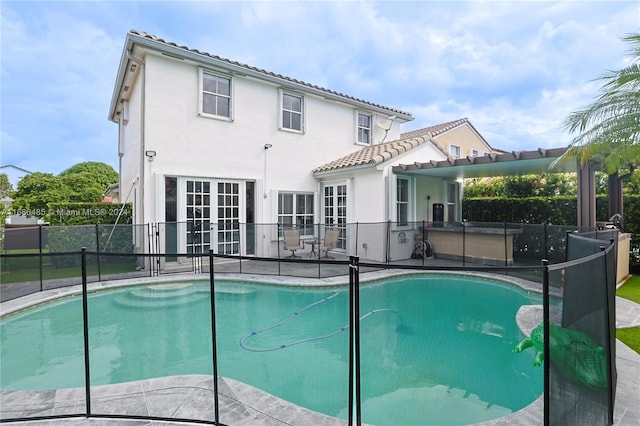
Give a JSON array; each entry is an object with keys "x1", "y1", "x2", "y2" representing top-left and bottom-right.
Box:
[{"x1": 0, "y1": 221, "x2": 626, "y2": 301}]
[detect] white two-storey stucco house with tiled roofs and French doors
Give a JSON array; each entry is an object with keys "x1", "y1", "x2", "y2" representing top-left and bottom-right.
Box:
[{"x1": 109, "y1": 30, "x2": 510, "y2": 259}]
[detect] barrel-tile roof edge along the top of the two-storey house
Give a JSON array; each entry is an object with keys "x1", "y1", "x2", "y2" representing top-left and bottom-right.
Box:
[{"x1": 129, "y1": 30, "x2": 413, "y2": 120}]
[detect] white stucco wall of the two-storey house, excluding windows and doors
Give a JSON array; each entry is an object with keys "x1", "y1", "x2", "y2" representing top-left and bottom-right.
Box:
[{"x1": 120, "y1": 50, "x2": 400, "y2": 255}]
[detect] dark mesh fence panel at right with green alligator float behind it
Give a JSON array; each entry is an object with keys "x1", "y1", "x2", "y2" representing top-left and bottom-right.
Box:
[{"x1": 549, "y1": 233, "x2": 616, "y2": 425}]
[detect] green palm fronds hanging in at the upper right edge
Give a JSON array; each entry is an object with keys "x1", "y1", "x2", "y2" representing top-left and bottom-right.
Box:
[{"x1": 561, "y1": 33, "x2": 640, "y2": 175}]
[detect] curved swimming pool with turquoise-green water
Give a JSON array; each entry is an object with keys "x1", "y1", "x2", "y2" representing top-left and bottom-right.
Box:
[{"x1": 0, "y1": 274, "x2": 543, "y2": 425}]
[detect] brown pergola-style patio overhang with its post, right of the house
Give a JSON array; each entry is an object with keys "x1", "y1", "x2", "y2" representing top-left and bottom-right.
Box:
[{"x1": 393, "y1": 148, "x2": 596, "y2": 227}]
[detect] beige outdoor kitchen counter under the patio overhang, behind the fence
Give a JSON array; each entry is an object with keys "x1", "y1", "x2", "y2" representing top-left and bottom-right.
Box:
[{"x1": 426, "y1": 225, "x2": 522, "y2": 266}]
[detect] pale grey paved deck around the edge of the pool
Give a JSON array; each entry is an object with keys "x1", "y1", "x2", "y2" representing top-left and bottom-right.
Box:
[{"x1": 0, "y1": 271, "x2": 640, "y2": 426}]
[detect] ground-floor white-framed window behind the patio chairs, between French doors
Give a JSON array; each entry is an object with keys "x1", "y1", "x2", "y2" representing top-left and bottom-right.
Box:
[{"x1": 278, "y1": 192, "x2": 314, "y2": 236}]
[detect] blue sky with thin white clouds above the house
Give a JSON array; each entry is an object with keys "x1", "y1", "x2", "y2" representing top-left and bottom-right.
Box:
[{"x1": 0, "y1": 0, "x2": 640, "y2": 180}]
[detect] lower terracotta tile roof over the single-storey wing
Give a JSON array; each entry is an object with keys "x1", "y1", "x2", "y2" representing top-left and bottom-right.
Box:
[{"x1": 313, "y1": 134, "x2": 430, "y2": 173}]
